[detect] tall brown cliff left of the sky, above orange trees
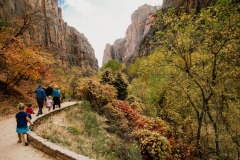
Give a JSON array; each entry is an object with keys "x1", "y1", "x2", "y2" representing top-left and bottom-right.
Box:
[{"x1": 0, "y1": 0, "x2": 99, "y2": 73}]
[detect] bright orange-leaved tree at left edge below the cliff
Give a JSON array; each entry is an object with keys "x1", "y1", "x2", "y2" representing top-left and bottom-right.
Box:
[{"x1": 0, "y1": 3, "x2": 51, "y2": 91}]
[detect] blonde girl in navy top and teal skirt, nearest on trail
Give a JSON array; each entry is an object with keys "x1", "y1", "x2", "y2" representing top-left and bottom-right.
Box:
[{"x1": 15, "y1": 103, "x2": 33, "y2": 146}]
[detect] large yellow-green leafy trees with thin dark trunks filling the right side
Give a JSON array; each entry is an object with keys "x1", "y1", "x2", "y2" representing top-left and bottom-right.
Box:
[{"x1": 129, "y1": 0, "x2": 240, "y2": 159}]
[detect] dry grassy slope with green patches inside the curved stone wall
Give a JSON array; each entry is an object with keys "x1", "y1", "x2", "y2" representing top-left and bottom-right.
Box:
[{"x1": 35, "y1": 103, "x2": 141, "y2": 160}]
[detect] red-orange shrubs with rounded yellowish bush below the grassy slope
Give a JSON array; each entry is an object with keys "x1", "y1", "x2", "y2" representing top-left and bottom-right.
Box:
[{"x1": 112, "y1": 100, "x2": 175, "y2": 159}]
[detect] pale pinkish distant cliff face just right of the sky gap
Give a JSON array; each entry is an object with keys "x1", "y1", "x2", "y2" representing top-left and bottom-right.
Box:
[{"x1": 103, "y1": 5, "x2": 158, "y2": 65}]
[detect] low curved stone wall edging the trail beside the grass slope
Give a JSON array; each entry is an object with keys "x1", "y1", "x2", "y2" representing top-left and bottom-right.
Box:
[{"x1": 27, "y1": 102, "x2": 90, "y2": 160}]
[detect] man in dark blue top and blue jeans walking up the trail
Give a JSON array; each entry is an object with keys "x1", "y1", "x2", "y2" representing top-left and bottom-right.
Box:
[{"x1": 35, "y1": 85, "x2": 46, "y2": 116}]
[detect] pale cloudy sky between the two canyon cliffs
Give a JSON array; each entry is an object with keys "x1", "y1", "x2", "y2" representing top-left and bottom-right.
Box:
[{"x1": 62, "y1": 0, "x2": 162, "y2": 67}]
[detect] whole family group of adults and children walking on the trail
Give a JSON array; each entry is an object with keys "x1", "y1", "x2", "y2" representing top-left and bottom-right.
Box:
[{"x1": 15, "y1": 85, "x2": 61, "y2": 146}]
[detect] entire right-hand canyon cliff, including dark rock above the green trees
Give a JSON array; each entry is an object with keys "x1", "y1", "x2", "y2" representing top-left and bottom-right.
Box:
[{"x1": 103, "y1": 0, "x2": 216, "y2": 65}]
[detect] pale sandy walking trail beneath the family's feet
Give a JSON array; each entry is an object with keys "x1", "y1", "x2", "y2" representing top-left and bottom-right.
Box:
[{"x1": 0, "y1": 102, "x2": 76, "y2": 160}]
